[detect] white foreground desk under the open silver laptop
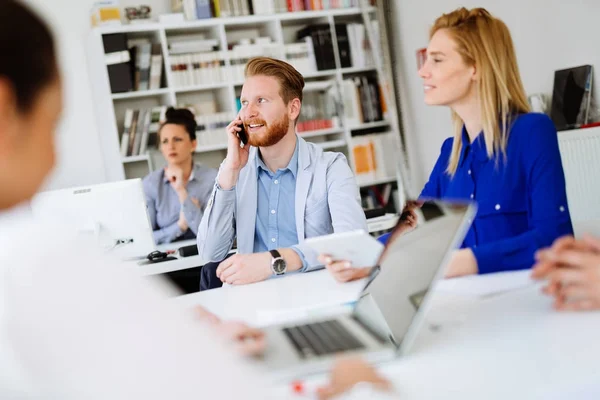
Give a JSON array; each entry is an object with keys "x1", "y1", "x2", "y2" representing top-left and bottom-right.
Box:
[{"x1": 172, "y1": 271, "x2": 600, "y2": 400}]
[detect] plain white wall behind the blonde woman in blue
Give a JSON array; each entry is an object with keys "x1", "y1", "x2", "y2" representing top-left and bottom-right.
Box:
[{"x1": 390, "y1": 0, "x2": 600, "y2": 194}]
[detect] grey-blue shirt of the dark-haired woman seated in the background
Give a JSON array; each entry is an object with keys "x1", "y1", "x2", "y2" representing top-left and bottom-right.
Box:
[{"x1": 143, "y1": 164, "x2": 217, "y2": 244}]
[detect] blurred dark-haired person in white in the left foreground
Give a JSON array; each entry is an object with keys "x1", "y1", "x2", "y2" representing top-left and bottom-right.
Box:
[{"x1": 0, "y1": 0, "x2": 394, "y2": 400}]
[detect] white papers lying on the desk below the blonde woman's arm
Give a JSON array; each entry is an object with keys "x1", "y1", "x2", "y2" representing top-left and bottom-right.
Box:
[{"x1": 434, "y1": 269, "x2": 539, "y2": 297}]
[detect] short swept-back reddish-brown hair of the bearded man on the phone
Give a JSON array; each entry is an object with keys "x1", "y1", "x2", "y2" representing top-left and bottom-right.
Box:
[{"x1": 244, "y1": 57, "x2": 304, "y2": 105}]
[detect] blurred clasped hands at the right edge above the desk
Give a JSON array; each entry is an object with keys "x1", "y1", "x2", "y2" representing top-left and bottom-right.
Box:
[{"x1": 532, "y1": 236, "x2": 600, "y2": 311}]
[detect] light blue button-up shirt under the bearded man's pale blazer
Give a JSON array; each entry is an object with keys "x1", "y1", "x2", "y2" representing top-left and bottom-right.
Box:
[{"x1": 254, "y1": 143, "x2": 306, "y2": 267}]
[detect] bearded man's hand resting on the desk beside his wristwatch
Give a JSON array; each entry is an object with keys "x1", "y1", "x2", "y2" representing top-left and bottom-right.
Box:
[{"x1": 217, "y1": 252, "x2": 273, "y2": 285}]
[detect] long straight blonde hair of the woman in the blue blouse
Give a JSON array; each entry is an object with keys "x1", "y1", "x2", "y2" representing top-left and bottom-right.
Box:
[{"x1": 429, "y1": 7, "x2": 530, "y2": 176}]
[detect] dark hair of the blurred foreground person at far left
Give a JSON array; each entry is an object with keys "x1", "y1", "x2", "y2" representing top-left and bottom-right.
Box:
[{"x1": 0, "y1": 0, "x2": 58, "y2": 111}]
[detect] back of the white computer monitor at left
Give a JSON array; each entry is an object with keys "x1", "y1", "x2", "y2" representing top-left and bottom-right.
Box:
[{"x1": 31, "y1": 179, "x2": 155, "y2": 259}]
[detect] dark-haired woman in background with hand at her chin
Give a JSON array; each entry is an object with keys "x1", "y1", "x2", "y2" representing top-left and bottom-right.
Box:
[{"x1": 144, "y1": 108, "x2": 217, "y2": 243}]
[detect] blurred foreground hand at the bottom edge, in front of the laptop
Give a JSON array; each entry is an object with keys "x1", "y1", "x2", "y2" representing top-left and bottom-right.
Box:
[{"x1": 317, "y1": 359, "x2": 392, "y2": 399}]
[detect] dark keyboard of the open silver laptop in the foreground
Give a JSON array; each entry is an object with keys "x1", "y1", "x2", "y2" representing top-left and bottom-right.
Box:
[{"x1": 283, "y1": 320, "x2": 364, "y2": 358}]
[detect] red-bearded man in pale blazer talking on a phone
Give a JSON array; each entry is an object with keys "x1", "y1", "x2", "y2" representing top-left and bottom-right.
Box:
[{"x1": 197, "y1": 57, "x2": 367, "y2": 290}]
